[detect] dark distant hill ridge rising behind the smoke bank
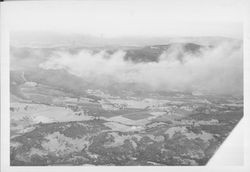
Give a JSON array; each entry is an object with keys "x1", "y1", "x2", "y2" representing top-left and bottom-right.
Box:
[{"x1": 10, "y1": 43, "x2": 207, "y2": 68}]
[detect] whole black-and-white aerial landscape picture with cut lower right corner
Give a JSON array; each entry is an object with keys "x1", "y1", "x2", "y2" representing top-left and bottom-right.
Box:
[{"x1": 1, "y1": 0, "x2": 249, "y2": 167}]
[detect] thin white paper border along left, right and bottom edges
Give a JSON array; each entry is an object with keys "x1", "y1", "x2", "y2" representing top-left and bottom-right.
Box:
[{"x1": 1, "y1": 1, "x2": 250, "y2": 172}]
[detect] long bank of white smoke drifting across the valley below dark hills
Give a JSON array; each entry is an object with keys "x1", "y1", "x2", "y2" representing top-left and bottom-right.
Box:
[{"x1": 40, "y1": 41, "x2": 243, "y2": 94}]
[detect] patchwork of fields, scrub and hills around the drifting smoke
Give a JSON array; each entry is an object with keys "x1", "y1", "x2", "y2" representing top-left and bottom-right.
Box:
[{"x1": 10, "y1": 38, "x2": 243, "y2": 166}]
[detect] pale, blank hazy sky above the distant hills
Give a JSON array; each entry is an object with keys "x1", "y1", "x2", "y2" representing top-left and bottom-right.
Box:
[{"x1": 3, "y1": 0, "x2": 244, "y2": 38}]
